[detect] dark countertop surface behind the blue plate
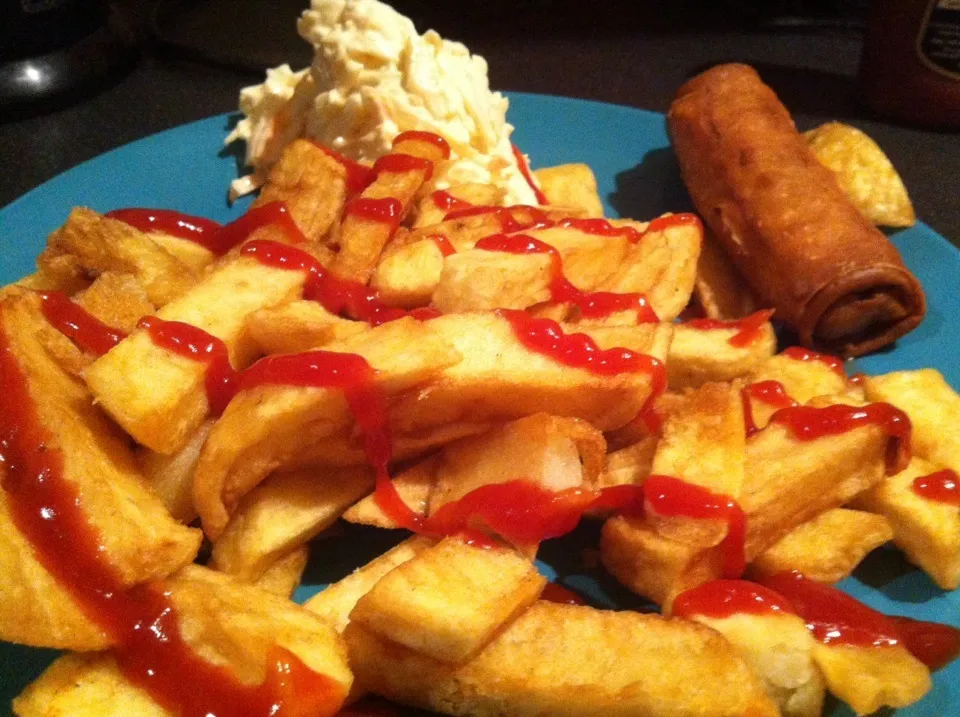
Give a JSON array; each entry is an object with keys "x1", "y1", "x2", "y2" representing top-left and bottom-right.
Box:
[{"x1": 0, "y1": 0, "x2": 960, "y2": 246}]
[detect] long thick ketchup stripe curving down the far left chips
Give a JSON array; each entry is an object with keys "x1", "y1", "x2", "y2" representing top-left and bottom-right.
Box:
[{"x1": 0, "y1": 332, "x2": 344, "y2": 717}]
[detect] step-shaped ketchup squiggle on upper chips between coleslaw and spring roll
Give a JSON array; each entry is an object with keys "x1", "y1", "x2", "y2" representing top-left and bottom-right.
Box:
[{"x1": 474, "y1": 234, "x2": 658, "y2": 323}]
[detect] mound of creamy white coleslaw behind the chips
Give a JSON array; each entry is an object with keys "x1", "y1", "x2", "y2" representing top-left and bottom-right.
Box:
[{"x1": 227, "y1": 0, "x2": 536, "y2": 204}]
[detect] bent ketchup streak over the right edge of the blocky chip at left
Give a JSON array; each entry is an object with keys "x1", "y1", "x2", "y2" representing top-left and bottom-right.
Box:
[{"x1": 137, "y1": 316, "x2": 238, "y2": 416}]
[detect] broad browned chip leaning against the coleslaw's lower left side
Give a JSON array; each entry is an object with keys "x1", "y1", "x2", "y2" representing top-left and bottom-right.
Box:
[{"x1": 253, "y1": 139, "x2": 347, "y2": 244}]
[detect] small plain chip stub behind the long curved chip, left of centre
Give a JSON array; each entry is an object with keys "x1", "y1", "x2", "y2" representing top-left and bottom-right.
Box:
[{"x1": 247, "y1": 299, "x2": 369, "y2": 354}]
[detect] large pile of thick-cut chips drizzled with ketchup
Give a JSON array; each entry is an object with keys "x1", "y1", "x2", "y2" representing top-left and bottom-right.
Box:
[{"x1": 0, "y1": 129, "x2": 960, "y2": 717}]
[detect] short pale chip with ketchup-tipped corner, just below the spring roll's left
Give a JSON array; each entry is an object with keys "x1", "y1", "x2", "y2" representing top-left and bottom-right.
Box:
[{"x1": 667, "y1": 323, "x2": 777, "y2": 389}]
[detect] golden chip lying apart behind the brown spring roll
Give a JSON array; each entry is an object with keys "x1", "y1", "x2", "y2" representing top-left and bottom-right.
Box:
[{"x1": 803, "y1": 122, "x2": 917, "y2": 227}]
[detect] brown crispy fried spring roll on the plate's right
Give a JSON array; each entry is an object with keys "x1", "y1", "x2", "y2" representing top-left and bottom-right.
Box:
[{"x1": 669, "y1": 65, "x2": 926, "y2": 356}]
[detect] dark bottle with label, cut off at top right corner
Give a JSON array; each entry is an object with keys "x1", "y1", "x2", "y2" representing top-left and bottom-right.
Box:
[{"x1": 860, "y1": 0, "x2": 960, "y2": 127}]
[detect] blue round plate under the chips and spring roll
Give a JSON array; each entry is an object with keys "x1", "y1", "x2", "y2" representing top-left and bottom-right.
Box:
[{"x1": 0, "y1": 93, "x2": 960, "y2": 717}]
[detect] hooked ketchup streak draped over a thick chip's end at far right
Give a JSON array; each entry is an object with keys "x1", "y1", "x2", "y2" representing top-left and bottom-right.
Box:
[{"x1": 770, "y1": 403, "x2": 911, "y2": 474}]
